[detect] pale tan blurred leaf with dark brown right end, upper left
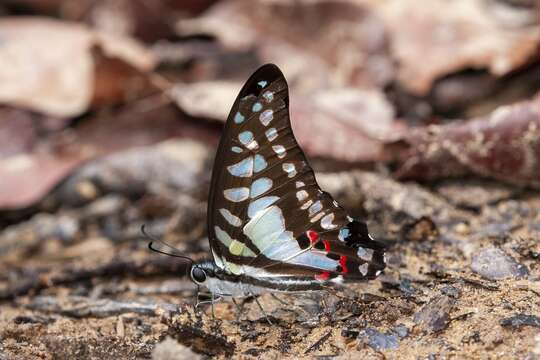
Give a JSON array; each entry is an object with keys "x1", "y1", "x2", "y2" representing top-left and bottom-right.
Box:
[{"x1": 0, "y1": 17, "x2": 154, "y2": 117}]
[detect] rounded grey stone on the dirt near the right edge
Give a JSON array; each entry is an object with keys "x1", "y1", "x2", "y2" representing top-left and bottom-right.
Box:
[{"x1": 471, "y1": 247, "x2": 528, "y2": 280}]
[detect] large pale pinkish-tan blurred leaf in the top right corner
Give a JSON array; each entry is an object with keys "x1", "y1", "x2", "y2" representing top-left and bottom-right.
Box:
[{"x1": 368, "y1": 0, "x2": 540, "y2": 95}]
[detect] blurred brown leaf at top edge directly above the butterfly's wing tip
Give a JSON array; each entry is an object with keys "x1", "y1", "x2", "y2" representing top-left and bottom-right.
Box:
[{"x1": 178, "y1": 0, "x2": 394, "y2": 92}]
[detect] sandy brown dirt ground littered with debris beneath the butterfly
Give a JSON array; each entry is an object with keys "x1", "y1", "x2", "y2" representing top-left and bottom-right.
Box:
[{"x1": 0, "y1": 156, "x2": 540, "y2": 359}]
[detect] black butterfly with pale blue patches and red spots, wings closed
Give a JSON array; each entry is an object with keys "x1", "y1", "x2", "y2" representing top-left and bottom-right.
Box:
[{"x1": 150, "y1": 64, "x2": 385, "y2": 304}]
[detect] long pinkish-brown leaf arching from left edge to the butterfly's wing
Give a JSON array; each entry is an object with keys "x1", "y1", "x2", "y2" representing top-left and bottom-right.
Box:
[{"x1": 0, "y1": 99, "x2": 219, "y2": 209}]
